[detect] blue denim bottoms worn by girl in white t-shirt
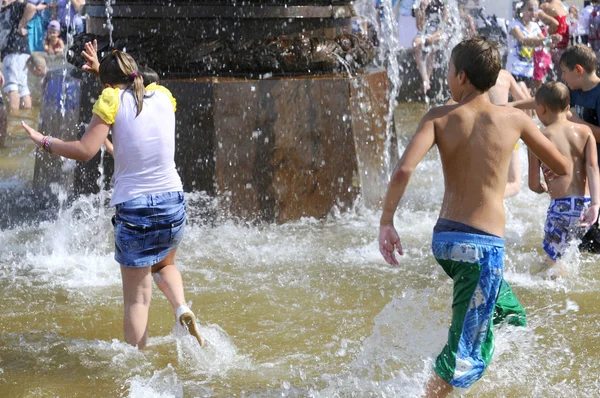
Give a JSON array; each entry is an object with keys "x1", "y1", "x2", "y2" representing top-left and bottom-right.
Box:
[{"x1": 112, "y1": 192, "x2": 185, "y2": 267}]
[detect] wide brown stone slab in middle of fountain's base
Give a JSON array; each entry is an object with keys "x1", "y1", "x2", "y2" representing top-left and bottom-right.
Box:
[{"x1": 272, "y1": 78, "x2": 357, "y2": 222}]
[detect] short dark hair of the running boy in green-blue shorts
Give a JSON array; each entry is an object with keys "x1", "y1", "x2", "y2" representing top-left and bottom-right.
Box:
[{"x1": 451, "y1": 37, "x2": 502, "y2": 91}]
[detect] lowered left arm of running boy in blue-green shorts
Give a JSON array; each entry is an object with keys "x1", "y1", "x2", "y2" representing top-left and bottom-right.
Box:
[{"x1": 379, "y1": 109, "x2": 439, "y2": 265}]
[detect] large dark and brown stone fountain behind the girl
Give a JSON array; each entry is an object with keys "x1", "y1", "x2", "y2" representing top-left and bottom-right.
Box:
[{"x1": 34, "y1": 0, "x2": 397, "y2": 222}]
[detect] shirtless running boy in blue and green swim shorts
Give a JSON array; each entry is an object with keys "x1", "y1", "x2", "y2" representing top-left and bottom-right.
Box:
[{"x1": 379, "y1": 38, "x2": 568, "y2": 397}]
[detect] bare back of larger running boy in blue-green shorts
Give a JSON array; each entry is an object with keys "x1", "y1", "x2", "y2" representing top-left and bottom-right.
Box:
[{"x1": 432, "y1": 96, "x2": 537, "y2": 236}]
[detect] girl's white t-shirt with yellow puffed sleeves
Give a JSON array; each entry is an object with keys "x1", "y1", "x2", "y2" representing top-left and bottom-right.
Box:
[{"x1": 94, "y1": 84, "x2": 183, "y2": 206}]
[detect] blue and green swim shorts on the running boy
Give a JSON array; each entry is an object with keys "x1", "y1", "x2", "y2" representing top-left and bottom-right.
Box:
[{"x1": 432, "y1": 232, "x2": 525, "y2": 388}]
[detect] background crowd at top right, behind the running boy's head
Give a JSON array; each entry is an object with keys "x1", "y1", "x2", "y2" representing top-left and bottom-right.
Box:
[{"x1": 407, "y1": 0, "x2": 600, "y2": 95}]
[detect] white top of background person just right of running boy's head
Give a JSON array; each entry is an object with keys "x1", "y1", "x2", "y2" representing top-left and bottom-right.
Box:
[{"x1": 506, "y1": 19, "x2": 542, "y2": 77}]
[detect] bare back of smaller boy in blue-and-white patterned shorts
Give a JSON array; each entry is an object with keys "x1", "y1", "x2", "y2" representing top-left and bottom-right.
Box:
[{"x1": 543, "y1": 120, "x2": 596, "y2": 199}]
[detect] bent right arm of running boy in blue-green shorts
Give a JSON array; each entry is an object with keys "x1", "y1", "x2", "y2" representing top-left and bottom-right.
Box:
[{"x1": 519, "y1": 114, "x2": 568, "y2": 176}]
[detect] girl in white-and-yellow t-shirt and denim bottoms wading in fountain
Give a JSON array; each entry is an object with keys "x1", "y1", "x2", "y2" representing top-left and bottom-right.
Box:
[{"x1": 22, "y1": 42, "x2": 202, "y2": 348}]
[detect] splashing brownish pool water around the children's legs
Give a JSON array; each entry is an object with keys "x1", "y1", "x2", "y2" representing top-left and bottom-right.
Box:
[{"x1": 0, "y1": 104, "x2": 600, "y2": 397}]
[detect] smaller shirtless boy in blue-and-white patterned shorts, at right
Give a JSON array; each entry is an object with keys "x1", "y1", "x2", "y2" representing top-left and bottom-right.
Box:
[{"x1": 529, "y1": 82, "x2": 600, "y2": 265}]
